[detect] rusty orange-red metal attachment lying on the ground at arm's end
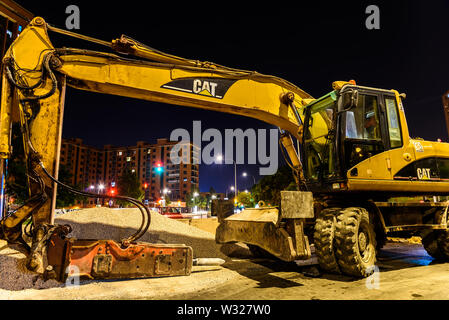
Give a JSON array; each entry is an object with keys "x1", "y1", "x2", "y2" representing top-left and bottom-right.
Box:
[{"x1": 47, "y1": 234, "x2": 193, "y2": 281}]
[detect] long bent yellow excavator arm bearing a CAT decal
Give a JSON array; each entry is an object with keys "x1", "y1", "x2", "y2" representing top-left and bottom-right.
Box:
[{"x1": 0, "y1": 17, "x2": 313, "y2": 278}]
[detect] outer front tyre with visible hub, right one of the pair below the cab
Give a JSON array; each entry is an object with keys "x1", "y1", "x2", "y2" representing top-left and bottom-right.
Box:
[{"x1": 335, "y1": 208, "x2": 377, "y2": 278}]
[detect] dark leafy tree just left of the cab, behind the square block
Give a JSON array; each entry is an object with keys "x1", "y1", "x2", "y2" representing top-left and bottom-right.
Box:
[{"x1": 251, "y1": 166, "x2": 298, "y2": 206}]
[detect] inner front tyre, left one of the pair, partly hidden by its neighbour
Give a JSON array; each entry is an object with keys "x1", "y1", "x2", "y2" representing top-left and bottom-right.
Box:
[{"x1": 313, "y1": 208, "x2": 341, "y2": 274}]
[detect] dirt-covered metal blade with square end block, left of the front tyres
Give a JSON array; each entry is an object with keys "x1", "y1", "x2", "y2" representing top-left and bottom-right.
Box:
[{"x1": 215, "y1": 191, "x2": 314, "y2": 261}]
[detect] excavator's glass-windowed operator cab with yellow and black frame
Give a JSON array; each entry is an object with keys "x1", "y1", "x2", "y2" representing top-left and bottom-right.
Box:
[{"x1": 301, "y1": 84, "x2": 403, "y2": 193}]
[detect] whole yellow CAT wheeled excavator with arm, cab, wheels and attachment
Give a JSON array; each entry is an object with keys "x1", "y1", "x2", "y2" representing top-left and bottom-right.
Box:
[{"x1": 0, "y1": 17, "x2": 449, "y2": 280}]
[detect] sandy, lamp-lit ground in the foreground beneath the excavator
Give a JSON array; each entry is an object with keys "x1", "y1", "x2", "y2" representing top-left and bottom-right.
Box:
[{"x1": 0, "y1": 243, "x2": 449, "y2": 300}]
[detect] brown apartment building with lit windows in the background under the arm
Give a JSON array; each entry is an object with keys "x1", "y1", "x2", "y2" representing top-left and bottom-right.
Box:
[{"x1": 60, "y1": 139, "x2": 199, "y2": 202}]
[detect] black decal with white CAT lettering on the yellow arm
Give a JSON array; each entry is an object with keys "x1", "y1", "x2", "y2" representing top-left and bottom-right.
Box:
[{"x1": 161, "y1": 78, "x2": 237, "y2": 99}]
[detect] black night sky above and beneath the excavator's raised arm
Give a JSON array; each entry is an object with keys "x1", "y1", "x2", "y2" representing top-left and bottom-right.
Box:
[{"x1": 16, "y1": 0, "x2": 449, "y2": 192}]
